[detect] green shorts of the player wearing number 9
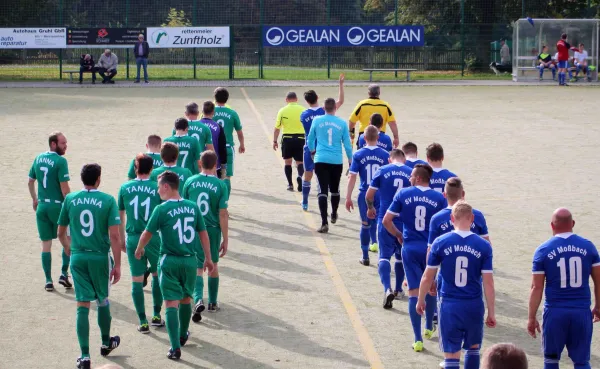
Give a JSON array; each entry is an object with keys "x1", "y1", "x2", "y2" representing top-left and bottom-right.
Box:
[{"x1": 71, "y1": 252, "x2": 112, "y2": 302}]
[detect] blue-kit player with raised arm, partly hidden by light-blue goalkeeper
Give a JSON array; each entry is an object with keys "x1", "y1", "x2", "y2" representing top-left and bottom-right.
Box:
[{"x1": 300, "y1": 73, "x2": 344, "y2": 211}]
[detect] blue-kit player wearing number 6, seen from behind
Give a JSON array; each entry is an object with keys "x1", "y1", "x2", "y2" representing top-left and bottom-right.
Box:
[{"x1": 417, "y1": 201, "x2": 496, "y2": 369}]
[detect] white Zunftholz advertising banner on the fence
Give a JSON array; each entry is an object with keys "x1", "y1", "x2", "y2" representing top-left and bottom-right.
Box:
[{"x1": 146, "y1": 27, "x2": 229, "y2": 49}]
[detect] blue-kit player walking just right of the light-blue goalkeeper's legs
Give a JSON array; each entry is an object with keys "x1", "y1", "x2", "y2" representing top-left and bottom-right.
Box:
[{"x1": 346, "y1": 126, "x2": 390, "y2": 266}]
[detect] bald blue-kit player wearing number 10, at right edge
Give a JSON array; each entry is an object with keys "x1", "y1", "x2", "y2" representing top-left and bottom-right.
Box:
[{"x1": 527, "y1": 208, "x2": 600, "y2": 369}]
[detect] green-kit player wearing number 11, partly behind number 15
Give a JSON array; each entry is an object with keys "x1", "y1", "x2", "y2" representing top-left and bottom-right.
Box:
[{"x1": 117, "y1": 154, "x2": 164, "y2": 334}]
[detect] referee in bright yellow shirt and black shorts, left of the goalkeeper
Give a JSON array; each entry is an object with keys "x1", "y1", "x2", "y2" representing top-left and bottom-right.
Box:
[{"x1": 273, "y1": 92, "x2": 304, "y2": 192}]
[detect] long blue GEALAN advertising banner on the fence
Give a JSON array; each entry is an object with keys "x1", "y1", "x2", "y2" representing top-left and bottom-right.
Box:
[{"x1": 262, "y1": 26, "x2": 425, "y2": 47}]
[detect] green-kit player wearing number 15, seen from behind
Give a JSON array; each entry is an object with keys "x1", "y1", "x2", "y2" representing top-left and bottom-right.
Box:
[{"x1": 135, "y1": 171, "x2": 213, "y2": 360}]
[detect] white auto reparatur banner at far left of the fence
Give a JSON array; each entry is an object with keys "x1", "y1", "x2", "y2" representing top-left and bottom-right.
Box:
[{"x1": 0, "y1": 27, "x2": 67, "y2": 49}]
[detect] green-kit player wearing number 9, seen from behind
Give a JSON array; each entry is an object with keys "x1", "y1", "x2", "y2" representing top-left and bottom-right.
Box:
[{"x1": 58, "y1": 164, "x2": 121, "y2": 369}]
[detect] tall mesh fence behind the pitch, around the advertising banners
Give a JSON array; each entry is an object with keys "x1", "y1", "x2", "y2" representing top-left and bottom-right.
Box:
[{"x1": 0, "y1": 0, "x2": 600, "y2": 79}]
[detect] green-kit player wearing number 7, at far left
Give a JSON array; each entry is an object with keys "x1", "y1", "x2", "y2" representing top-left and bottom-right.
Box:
[{"x1": 28, "y1": 132, "x2": 73, "y2": 292}]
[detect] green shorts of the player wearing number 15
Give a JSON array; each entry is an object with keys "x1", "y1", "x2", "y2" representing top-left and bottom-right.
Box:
[{"x1": 158, "y1": 255, "x2": 196, "y2": 301}]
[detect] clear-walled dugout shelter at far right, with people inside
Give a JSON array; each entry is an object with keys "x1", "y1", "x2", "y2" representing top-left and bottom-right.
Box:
[{"x1": 512, "y1": 18, "x2": 600, "y2": 81}]
